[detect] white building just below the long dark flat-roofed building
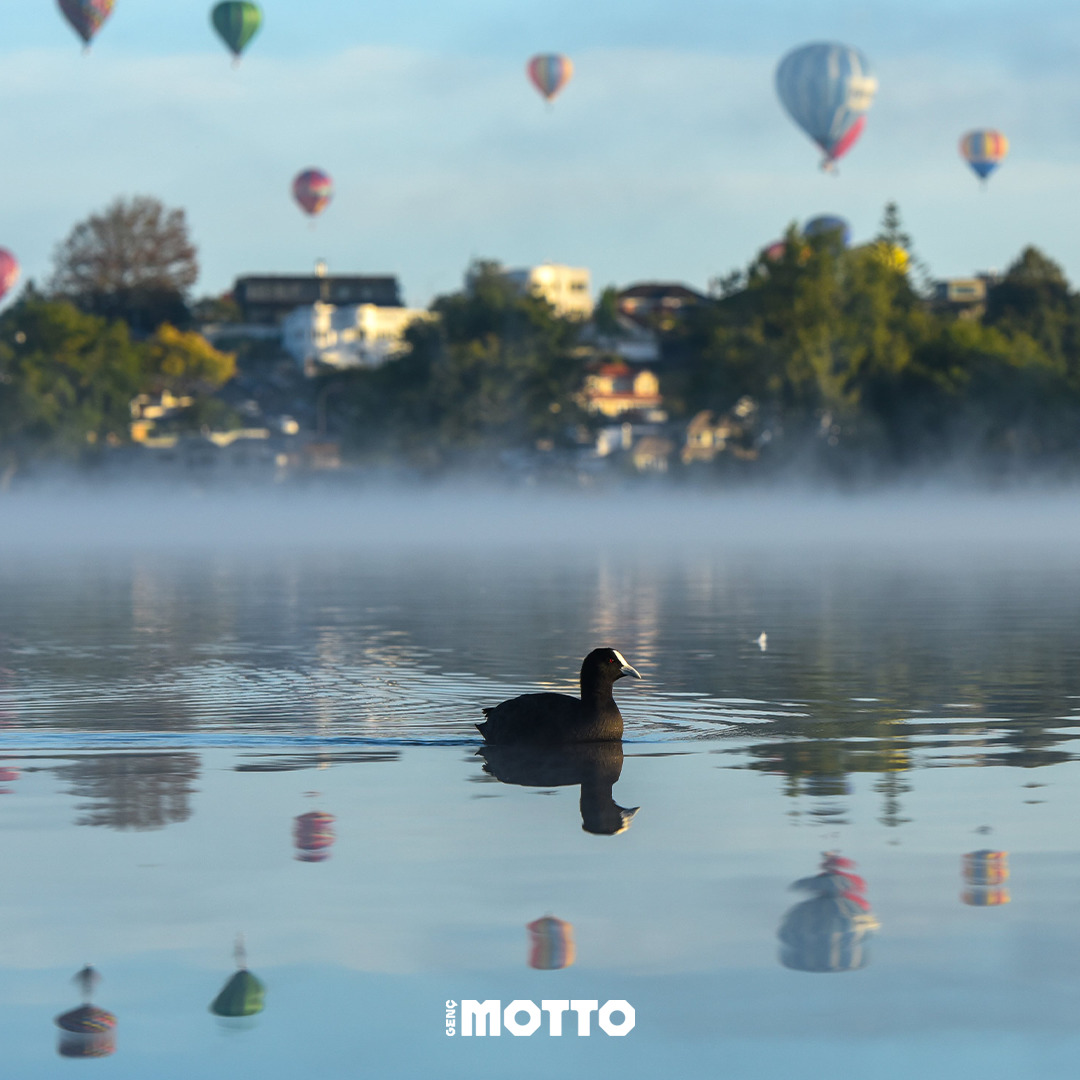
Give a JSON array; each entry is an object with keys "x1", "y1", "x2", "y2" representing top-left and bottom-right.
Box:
[{"x1": 281, "y1": 302, "x2": 434, "y2": 375}]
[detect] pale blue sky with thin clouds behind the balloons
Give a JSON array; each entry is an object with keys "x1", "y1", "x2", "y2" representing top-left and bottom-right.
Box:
[{"x1": 0, "y1": 0, "x2": 1080, "y2": 303}]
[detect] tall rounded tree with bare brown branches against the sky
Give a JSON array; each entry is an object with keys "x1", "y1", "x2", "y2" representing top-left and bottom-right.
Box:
[{"x1": 50, "y1": 195, "x2": 199, "y2": 334}]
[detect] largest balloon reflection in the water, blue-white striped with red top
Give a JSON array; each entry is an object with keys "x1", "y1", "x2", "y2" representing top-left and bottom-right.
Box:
[{"x1": 778, "y1": 851, "x2": 880, "y2": 971}]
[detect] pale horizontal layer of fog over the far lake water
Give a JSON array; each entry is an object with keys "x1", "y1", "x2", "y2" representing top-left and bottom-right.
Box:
[{"x1": 0, "y1": 485, "x2": 1080, "y2": 558}]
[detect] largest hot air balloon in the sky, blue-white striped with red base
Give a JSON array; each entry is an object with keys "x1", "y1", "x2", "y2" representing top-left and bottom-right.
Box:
[{"x1": 777, "y1": 42, "x2": 878, "y2": 170}]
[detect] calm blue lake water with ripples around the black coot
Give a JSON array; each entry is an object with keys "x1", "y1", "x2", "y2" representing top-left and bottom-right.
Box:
[{"x1": 6, "y1": 495, "x2": 1080, "y2": 1080}]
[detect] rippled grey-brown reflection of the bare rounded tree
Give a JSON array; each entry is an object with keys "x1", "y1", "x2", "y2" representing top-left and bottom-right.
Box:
[{"x1": 56, "y1": 752, "x2": 200, "y2": 829}]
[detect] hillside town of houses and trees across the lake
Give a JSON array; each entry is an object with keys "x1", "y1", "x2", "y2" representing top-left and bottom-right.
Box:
[{"x1": 0, "y1": 199, "x2": 1080, "y2": 485}]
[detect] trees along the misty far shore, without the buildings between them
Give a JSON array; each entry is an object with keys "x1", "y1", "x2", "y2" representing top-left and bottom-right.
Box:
[{"x1": 6, "y1": 198, "x2": 1080, "y2": 475}]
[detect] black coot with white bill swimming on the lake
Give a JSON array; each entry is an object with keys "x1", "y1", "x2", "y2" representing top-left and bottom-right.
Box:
[{"x1": 476, "y1": 649, "x2": 642, "y2": 745}]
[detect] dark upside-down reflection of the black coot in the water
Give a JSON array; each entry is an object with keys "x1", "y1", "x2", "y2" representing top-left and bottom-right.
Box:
[{"x1": 476, "y1": 742, "x2": 639, "y2": 836}]
